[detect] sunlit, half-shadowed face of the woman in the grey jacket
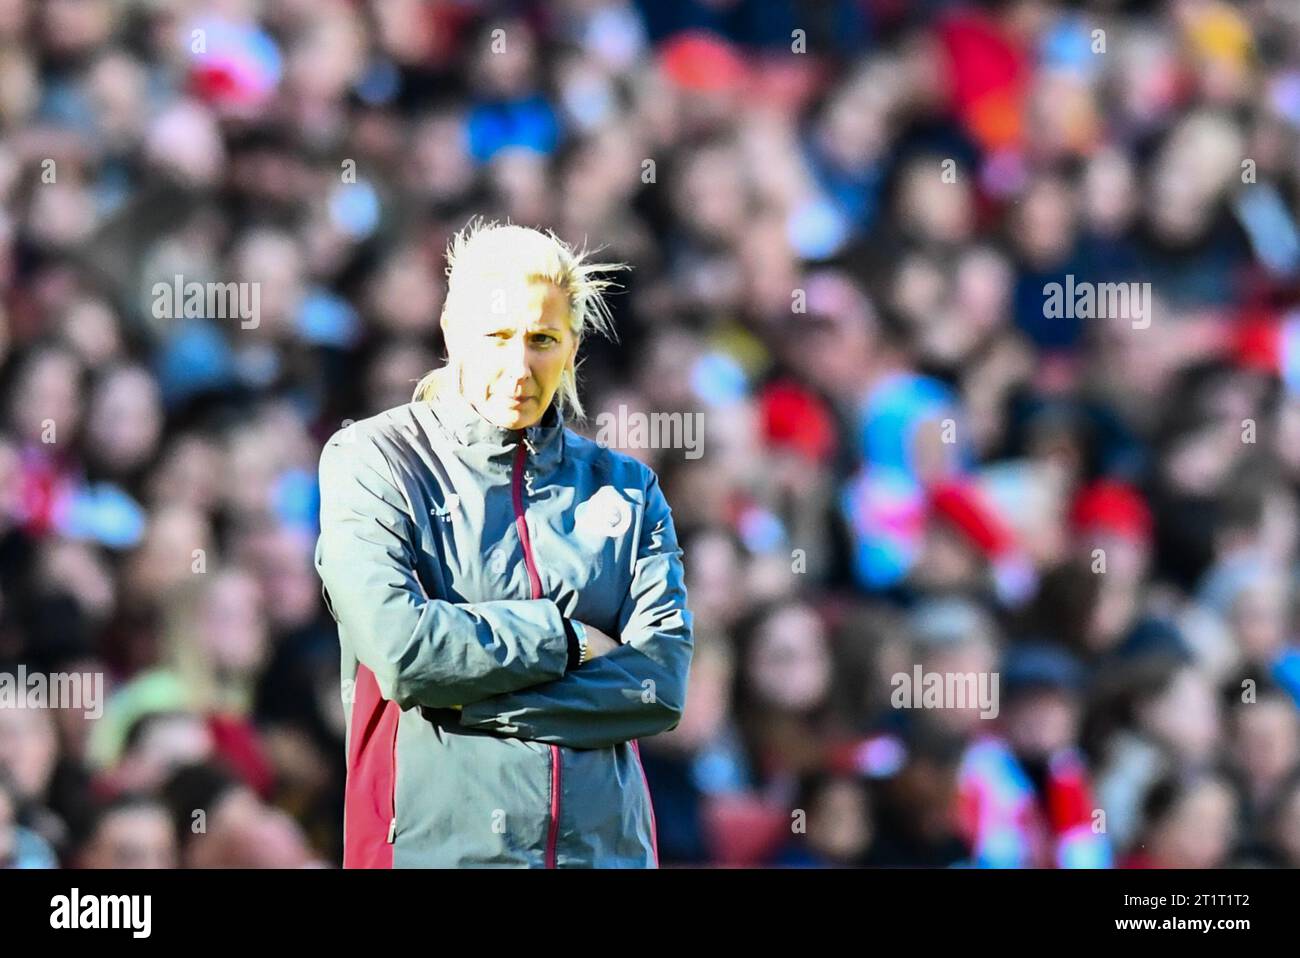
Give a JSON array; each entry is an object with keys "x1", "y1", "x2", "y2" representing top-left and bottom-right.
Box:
[{"x1": 443, "y1": 274, "x2": 577, "y2": 429}]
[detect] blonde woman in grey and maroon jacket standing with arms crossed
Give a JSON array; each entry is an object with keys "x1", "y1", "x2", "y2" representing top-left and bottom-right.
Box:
[{"x1": 316, "y1": 222, "x2": 693, "y2": 868}]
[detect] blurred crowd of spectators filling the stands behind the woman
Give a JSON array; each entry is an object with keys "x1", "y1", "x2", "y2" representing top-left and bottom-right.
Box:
[{"x1": 0, "y1": 0, "x2": 1300, "y2": 867}]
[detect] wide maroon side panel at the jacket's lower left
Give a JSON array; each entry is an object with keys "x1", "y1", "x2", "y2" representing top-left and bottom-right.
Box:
[{"x1": 343, "y1": 664, "x2": 402, "y2": 868}]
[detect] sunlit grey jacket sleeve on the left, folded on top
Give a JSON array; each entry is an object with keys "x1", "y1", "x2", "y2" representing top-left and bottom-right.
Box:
[{"x1": 316, "y1": 433, "x2": 569, "y2": 710}]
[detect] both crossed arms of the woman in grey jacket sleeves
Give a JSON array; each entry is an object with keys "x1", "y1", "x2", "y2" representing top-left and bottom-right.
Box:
[{"x1": 316, "y1": 434, "x2": 693, "y2": 747}]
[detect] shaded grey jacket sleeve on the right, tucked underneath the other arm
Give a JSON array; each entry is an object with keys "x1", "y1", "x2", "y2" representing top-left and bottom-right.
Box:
[{"x1": 462, "y1": 472, "x2": 694, "y2": 749}]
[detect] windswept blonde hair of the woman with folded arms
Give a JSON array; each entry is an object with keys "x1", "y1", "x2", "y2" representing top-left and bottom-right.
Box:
[{"x1": 412, "y1": 217, "x2": 628, "y2": 421}]
